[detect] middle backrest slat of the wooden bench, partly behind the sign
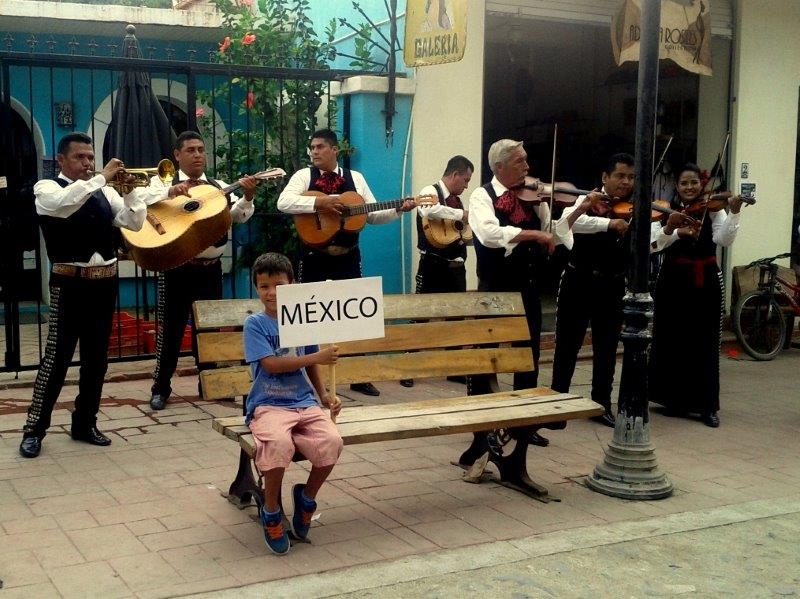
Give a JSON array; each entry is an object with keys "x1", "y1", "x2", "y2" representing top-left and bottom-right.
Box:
[{"x1": 197, "y1": 316, "x2": 530, "y2": 364}]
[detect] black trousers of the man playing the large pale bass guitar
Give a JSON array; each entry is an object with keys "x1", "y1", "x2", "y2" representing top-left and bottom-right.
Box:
[{"x1": 152, "y1": 262, "x2": 222, "y2": 395}]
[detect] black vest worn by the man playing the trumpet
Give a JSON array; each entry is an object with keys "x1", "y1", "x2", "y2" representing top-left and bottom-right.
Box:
[{"x1": 39, "y1": 178, "x2": 117, "y2": 264}]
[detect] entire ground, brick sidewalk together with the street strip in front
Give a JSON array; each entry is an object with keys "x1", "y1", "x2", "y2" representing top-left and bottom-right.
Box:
[{"x1": 0, "y1": 350, "x2": 800, "y2": 599}]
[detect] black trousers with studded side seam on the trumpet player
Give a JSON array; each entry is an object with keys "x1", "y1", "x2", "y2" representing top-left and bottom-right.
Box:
[{"x1": 23, "y1": 274, "x2": 117, "y2": 438}]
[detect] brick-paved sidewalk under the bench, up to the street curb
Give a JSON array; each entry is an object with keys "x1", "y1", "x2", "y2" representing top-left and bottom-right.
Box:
[{"x1": 0, "y1": 351, "x2": 800, "y2": 599}]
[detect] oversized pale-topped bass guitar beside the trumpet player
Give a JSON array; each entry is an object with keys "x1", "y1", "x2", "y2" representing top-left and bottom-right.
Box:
[{"x1": 122, "y1": 168, "x2": 286, "y2": 271}]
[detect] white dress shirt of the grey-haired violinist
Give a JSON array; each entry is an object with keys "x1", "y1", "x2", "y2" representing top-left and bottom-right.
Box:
[{"x1": 469, "y1": 177, "x2": 573, "y2": 256}]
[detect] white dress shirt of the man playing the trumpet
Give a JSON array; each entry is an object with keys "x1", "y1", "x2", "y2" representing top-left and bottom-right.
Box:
[{"x1": 33, "y1": 173, "x2": 167, "y2": 266}]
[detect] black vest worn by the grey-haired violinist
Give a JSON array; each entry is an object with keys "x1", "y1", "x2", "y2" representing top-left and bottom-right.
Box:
[{"x1": 473, "y1": 182, "x2": 543, "y2": 291}]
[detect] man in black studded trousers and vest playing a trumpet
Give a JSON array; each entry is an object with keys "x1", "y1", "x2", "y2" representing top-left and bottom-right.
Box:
[{"x1": 19, "y1": 133, "x2": 176, "y2": 458}]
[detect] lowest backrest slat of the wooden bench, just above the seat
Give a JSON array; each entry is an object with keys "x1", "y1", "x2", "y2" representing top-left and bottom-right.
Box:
[{"x1": 200, "y1": 347, "x2": 533, "y2": 400}]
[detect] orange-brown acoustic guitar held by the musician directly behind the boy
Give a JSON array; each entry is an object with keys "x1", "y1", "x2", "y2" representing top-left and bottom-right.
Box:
[{"x1": 293, "y1": 191, "x2": 439, "y2": 247}]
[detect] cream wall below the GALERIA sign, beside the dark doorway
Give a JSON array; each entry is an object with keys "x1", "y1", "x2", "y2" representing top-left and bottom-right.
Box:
[{"x1": 408, "y1": 0, "x2": 486, "y2": 291}]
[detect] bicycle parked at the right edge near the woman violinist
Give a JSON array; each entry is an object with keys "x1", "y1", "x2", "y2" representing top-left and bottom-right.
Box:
[{"x1": 733, "y1": 253, "x2": 800, "y2": 360}]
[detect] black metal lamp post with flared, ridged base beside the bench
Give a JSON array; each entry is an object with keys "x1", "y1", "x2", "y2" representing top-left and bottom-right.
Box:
[{"x1": 587, "y1": 0, "x2": 672, "y2": 499}]
